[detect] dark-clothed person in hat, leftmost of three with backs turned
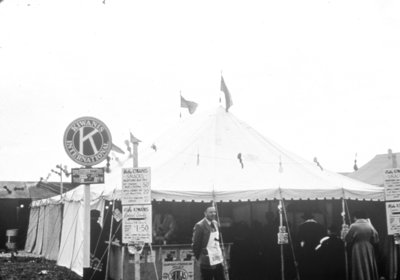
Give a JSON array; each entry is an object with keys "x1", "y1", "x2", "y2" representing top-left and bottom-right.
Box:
[{"x1": 297, "y1": 211, "x2": 326, "y2": 280}]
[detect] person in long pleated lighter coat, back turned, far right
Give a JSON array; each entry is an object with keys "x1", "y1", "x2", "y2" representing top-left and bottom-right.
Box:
[{"x1": 345, "y1": 211, "x2": 379, "y2": 280}]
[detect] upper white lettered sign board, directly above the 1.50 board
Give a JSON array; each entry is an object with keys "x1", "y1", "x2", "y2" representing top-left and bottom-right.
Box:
[{"x1": 121, "y1": 167, "x2": 151, "y2": 205}]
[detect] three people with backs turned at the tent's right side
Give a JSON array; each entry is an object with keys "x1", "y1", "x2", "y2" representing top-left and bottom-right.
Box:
[{"x1": 297, "y1": 211, "x2": 379, "y2": 280}]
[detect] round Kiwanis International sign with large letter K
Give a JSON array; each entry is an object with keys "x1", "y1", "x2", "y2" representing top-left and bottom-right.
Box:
[{"x1": 64, "y1": 117, "x2": 112, "y2": 166}]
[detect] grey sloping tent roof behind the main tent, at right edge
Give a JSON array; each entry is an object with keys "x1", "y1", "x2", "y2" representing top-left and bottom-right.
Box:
[{"x1": 347, "y1": 153, "x2": 400, "y2": 187}]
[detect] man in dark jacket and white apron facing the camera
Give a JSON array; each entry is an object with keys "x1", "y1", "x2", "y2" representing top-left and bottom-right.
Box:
[{"x1": 192, "y1": 206, "x2": 225, "y2": 280}]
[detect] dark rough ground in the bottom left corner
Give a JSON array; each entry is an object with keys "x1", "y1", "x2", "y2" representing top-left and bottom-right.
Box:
[{"x1": 0, "y1": 252, "x2": 82, "y2": 280}]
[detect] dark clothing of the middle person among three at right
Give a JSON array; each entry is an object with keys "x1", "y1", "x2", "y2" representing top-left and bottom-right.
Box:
[{"x1": 316, "y1": 235, "x2": 346, "y2": 280}]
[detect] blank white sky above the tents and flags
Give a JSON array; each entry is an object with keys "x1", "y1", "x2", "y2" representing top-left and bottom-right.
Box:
[{"x1": 0, "y1": 0, "x2": 400, "y2": 181}]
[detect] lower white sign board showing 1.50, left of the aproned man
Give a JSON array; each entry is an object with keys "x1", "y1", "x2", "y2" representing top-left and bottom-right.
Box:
[{"x1": 122, "y1": 205, "x2": 153, "y2": 243}]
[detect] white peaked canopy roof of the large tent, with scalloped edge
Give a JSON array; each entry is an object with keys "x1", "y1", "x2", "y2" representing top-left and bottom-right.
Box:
[{"x1": 134, "y1": 107, "x2": 382, "y2": 201}]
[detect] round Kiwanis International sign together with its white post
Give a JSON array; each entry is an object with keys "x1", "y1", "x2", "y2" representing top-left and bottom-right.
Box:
[{"x1": 64, "y1": 117, "x2": 112, "y2": 275}]
